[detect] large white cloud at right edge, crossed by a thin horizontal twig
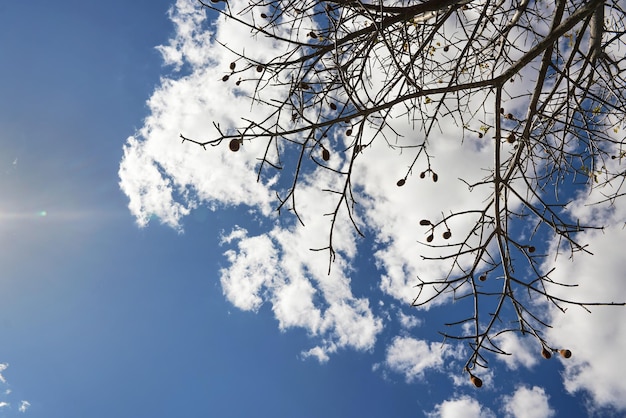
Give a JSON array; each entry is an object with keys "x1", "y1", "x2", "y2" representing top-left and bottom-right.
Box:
[{"x1": 532, "y1": 142, "x2": 626, "y2": 410}]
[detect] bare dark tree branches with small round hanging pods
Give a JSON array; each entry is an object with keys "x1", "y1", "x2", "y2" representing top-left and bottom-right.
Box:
[{"x1": 181, "y1": 0, "x2": 626, "y2": 387}]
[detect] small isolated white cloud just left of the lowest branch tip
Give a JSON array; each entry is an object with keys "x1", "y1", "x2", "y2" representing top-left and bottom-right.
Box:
[{"x1": 384, "y1": 336, "x2": 459, "y2": 382}]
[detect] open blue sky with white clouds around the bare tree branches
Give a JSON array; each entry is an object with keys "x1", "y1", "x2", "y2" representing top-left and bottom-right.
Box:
[{"x1": 0, "y1": 0, "x2": 626, "y2": 418}]
